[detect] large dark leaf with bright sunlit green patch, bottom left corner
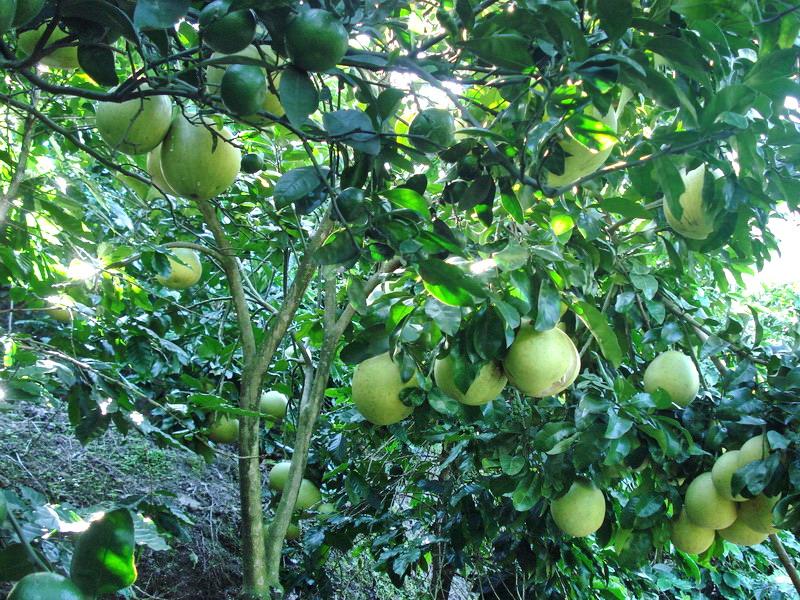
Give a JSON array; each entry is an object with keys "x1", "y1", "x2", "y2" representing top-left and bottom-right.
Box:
[{"x1": 70, "y1": 508, "x2": 136, "y2": 597}]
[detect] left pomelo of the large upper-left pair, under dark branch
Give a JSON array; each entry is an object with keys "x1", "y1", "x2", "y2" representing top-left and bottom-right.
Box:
[{"x1": 96, "y1": 86, "x2": 172, "y2": 154}]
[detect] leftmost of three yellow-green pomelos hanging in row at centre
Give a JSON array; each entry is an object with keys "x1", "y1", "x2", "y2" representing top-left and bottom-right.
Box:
[{"x1": 352, "y1": 352, "x2": 418, "y2": 425}]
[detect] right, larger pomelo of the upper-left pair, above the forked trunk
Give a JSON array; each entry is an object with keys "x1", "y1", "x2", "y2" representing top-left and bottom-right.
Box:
[{"x1": 161, "y1": 115, "x2": 242, "y2": 200}]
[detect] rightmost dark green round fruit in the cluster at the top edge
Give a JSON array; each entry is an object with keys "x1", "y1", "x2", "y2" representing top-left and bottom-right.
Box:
[{"x1": 286, "y1": 8, "x2": 348, "y2": 71}]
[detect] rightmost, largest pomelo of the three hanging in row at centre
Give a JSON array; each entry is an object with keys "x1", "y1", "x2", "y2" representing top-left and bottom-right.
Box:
[{"x1": 503, "y1": 325, "x2": 581, "y2": 398}]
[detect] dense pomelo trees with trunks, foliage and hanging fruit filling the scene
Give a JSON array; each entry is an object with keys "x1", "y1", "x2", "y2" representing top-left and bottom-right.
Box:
[{"x1": 0, "y1": 0, "x2": 800, "y2": 598}]
